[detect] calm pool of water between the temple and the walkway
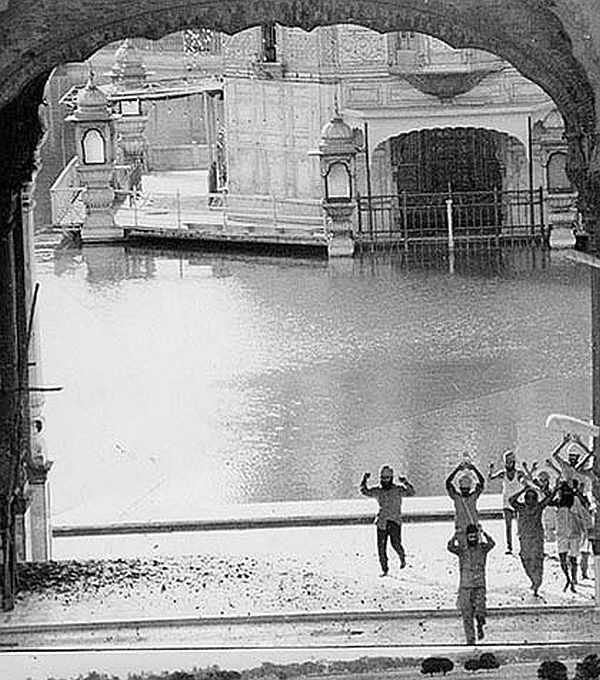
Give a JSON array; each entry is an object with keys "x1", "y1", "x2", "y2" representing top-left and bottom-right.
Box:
[{"x1": 37, "y1": 244, "x2": 591, "y2": 523}]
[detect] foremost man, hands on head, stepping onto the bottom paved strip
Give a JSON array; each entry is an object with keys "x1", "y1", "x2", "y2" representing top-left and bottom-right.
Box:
[{"x1": 448, "y1": 524, "x2": 496, "y2": 645}]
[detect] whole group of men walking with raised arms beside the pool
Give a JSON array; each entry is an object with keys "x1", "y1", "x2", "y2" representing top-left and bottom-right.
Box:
[{"x1": 360, "y1": 434, "x2": 600, "y2": 644}]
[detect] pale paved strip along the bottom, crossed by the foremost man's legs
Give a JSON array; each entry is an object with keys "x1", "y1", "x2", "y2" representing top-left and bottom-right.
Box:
[{"x1": 0, "y1": 607, "x2": 600, "y2": 649}]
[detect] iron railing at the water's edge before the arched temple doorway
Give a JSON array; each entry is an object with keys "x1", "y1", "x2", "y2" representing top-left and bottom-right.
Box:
[{"x1": 357, "y1": 187, "x2": 546, "y2": 246}]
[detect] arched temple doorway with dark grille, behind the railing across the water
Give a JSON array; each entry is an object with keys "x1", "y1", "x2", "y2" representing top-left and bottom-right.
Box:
[{"x1": 359, "y1": 127, "x2": 532, "y2": 246}]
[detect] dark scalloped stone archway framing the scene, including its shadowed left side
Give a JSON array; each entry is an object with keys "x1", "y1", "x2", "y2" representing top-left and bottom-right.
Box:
[{"x1": 0, "y1": 0, "x2": 600, "y2": 607}]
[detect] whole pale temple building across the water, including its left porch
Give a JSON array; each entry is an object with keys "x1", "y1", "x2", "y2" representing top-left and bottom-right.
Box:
[{"x1": 42, "y1": 24, "x2": 577, "y2": 239}]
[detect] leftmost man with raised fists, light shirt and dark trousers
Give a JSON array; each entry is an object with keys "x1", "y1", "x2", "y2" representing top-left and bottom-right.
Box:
[{"x1": 360, "y1": 465, "x2": 415, "y2": 576}]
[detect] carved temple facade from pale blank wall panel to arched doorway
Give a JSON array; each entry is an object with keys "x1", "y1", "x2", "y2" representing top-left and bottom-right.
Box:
[{"x1": 223, "y1": 25, "x2": 574, "y2": 226}]
